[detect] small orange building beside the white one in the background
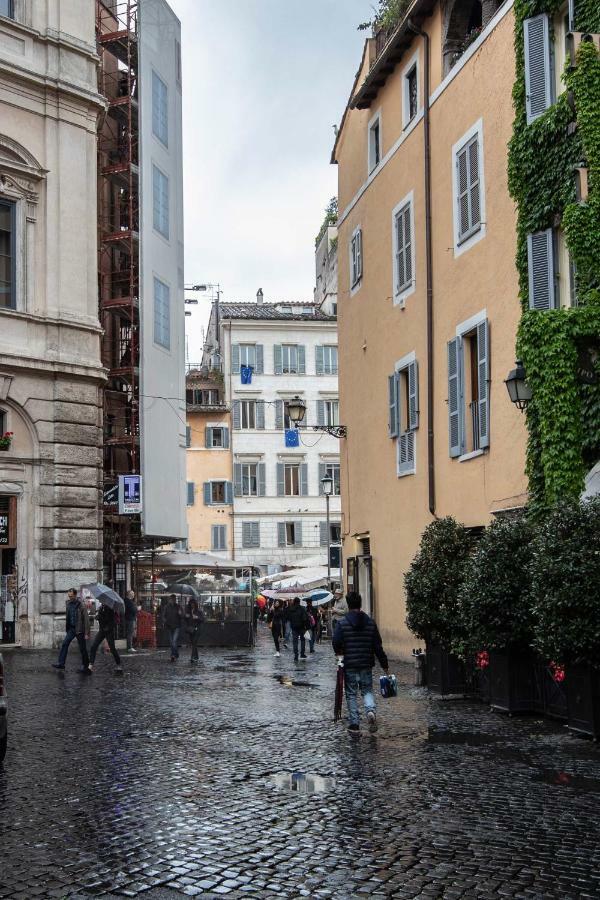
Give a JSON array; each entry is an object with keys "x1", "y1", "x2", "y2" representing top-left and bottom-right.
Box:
[{"x1": 186, "y1": 366, "x2": 233, "y2": 557}]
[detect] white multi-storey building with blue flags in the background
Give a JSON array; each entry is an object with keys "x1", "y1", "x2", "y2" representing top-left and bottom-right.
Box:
[{"x1": 204, "y1": 291, "x2": 341, "y2": 572}]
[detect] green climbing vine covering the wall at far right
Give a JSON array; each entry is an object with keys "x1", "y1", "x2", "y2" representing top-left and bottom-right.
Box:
[{"x1": 508, "y1": 0, "x2": 600, "y2": 510}]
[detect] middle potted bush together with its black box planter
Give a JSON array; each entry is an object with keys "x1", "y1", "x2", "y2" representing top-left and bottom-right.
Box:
[{"x1": 455, "y1": 516, "x2": 542, "y2": 713}]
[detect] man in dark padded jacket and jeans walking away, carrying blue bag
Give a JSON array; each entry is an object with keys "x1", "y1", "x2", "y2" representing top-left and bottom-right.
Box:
[{"x1": 333, "y1": 591, "x2": 388, "y2": 732}]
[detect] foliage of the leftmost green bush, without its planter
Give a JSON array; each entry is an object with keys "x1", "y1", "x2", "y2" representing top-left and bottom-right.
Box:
[{"x1": 404, "y1": 516, "x2": 473, "y2": 649}]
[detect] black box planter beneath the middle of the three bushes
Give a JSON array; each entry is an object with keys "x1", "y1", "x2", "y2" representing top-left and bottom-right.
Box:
[{"x1": 488, "y1": 650, "x2": 542, "y2": 714}]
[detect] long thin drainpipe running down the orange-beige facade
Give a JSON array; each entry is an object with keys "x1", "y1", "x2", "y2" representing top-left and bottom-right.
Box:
[{"x1": 408, "y1": 19, "x2": 435, "y2": 516}]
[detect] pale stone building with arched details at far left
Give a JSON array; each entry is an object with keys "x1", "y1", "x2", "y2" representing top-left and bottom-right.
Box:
[{"x1": 0, "y1": 0, "x2": 105, "y2": 647}]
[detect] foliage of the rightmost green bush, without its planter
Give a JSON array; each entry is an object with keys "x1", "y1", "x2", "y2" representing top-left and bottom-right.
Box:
[{"x1": 531, "y1": 499, "x2": 600, "y2": 666}]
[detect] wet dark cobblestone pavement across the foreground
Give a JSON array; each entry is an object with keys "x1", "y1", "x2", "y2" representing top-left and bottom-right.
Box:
[{"x1": 0, "y1": 629, "x2": 600, "y2": 900}]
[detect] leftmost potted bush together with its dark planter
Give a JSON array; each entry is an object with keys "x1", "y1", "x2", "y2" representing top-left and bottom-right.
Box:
[{"x1": 404, "y1": 516, "x2": 473, "y2": 694}]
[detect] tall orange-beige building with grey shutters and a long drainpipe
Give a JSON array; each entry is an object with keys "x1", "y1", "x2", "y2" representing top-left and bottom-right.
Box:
[{"x1": 333, "y1": 0, "x2": 526, "y2": 655}]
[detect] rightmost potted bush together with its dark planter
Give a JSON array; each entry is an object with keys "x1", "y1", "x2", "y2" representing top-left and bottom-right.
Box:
[{"x1": 532, "y1": 499, "x2": 600, "y2": 738}]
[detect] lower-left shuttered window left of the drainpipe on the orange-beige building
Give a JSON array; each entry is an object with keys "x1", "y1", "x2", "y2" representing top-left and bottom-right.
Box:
[{"x1": 388, "y1": 353, "x2": 419, "y2": 475}]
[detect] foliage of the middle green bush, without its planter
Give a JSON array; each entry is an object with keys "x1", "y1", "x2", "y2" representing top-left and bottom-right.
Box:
[{"x1": 454, "y1": 517, "x2": 534, "y2": 656}]
